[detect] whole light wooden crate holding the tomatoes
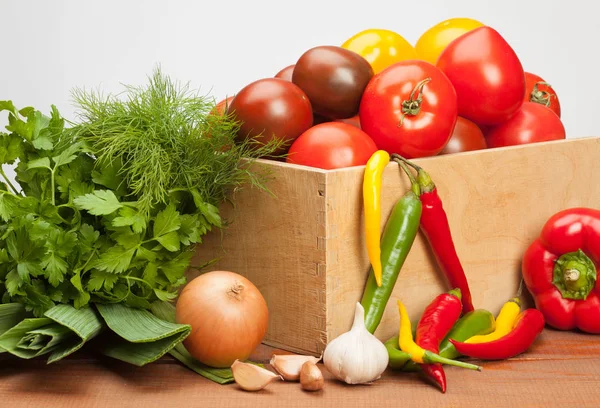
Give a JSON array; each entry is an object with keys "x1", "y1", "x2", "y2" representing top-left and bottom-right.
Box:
[{"x1": 190, "y1": 137, "x2": 600, "y2": 355}]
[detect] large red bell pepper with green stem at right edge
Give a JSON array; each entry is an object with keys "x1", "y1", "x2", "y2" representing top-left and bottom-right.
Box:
[{"x1": 522, "y1": 208, "x2": 600, "y2": 334}]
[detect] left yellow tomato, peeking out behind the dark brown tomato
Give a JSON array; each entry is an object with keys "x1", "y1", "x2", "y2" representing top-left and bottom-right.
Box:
[{"x1": 342, "y1": 28, "x2": 417, "y2": 74}]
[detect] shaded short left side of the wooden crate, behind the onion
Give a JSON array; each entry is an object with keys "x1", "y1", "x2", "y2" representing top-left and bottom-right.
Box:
[{"x1": 188, "y1": 161, "x2": 327, "y2": 351}]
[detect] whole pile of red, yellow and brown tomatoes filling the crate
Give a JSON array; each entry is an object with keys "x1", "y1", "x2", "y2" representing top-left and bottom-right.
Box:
[{"x1": 215, "y1": 18, "x2": 566, "y2": 169}]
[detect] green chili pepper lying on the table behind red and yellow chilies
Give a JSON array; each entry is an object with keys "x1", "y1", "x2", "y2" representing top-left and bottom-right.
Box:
[{"x1": 398, "y1": 309, "x2": 496, "y2": 372}]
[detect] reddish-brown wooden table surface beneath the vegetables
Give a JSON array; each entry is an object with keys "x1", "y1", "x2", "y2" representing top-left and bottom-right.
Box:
[{"x1": 0, "y1": 329, "x2": 600, "y2": 408}]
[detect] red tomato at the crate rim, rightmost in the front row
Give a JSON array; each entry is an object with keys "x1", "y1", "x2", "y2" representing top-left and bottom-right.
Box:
[{"x1": 486, "y1": 102, "x2": 566, "y2": 147}]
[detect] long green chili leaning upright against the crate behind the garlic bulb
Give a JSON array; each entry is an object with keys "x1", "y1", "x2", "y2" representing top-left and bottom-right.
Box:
[{"x1": 361, "y1": 175, "x2": 422, "y2": 333}]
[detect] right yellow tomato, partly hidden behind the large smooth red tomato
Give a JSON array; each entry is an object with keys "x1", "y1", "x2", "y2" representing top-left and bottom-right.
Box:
[{"x1": 415, "y1": 18, "x2": 483, "y2": 64}]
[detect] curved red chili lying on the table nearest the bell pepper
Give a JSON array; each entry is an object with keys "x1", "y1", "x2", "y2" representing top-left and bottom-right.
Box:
[{"x1": 450, "y1": 309, "x2": 545, "y2": 360}]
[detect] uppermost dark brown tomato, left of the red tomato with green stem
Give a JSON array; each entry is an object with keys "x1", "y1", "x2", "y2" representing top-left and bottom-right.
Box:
[{"x1": 292, "y1": 46, "x2": 373, "y2": 119}]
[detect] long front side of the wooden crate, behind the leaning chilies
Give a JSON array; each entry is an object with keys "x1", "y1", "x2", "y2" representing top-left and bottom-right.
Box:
[{"x1": 327, "y1": 138, "x2": 600, "y2": 340}]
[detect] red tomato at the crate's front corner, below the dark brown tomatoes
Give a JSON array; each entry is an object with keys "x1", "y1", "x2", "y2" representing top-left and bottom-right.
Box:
[{"x1": 286, "y1": 122, "x2": 377, "y2": 170}]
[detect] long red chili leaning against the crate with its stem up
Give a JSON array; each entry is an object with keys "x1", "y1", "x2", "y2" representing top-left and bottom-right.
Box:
[{"x1": 392, "y1": 154, "x2": 474, "y2": 313}]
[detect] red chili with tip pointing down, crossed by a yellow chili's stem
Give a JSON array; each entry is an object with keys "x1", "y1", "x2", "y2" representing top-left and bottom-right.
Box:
[{"x1": 415, "y1": 289, "x2": 462, "y2": 392}]
